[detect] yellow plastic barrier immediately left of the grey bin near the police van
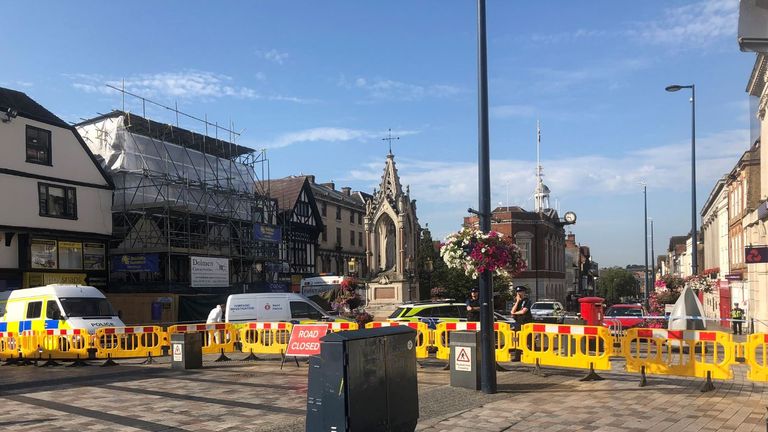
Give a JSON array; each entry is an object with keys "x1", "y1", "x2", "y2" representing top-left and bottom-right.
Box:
[{"x1": 93, "y1": 326, "x2": 168, "y2": 359}]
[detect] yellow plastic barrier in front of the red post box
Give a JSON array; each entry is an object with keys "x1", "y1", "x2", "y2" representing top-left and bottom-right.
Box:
[{"x1": 517, "y1": 323, "x2": 613, "y2": 370}]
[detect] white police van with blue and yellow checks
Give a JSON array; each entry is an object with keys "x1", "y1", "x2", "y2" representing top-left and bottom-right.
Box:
[{"x1": 0, "y1": 285, "x2": 125, "y2": 333}]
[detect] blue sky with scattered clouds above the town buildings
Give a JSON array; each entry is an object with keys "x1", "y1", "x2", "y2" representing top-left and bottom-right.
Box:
[{"x1": 0, "y1": 0, "x2": 754, "y2": 266}]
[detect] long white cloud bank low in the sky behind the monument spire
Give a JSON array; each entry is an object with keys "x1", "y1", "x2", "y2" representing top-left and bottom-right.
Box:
[{"x1": 348, "y1": 130, "x2": 749, "y2": 207}]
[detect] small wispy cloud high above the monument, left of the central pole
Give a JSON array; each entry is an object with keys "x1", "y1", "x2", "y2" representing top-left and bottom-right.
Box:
[{"x1": 339, "y1": 76, "x2": 463, "y2": 101}]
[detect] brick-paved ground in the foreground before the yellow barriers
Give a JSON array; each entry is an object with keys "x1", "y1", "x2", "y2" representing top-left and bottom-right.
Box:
[{"x1": 0, "y1": 355, "x2": 768, "y2": 432}]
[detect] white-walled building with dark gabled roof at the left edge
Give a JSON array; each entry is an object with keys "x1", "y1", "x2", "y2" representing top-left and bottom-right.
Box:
[{"x1": 0, "y1": 88, "x2": 114, "y2": 291}]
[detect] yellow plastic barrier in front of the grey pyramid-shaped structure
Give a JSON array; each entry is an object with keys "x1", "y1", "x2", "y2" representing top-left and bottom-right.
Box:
[{"x1": 622, "y1": 328, "x2": 735, "y2": 382}]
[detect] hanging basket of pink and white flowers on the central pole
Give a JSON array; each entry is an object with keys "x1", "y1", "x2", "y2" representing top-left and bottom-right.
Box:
[{"x1": 440, "y1": 228, "x2": 526, "y2": 279}]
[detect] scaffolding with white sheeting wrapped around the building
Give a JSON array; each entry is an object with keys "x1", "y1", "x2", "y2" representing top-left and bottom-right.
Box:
[{"x1": 76, "y1": 91, "x2": 279, "y2": 292}]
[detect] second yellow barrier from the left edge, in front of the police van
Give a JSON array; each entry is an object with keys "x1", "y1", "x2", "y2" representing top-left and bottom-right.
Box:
[{"x1": 19, "y1": 329, "x2": 92, "y2": 360}]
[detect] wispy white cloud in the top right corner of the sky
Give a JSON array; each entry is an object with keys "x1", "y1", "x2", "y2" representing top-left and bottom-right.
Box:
[{"x1": 629, "y1": 0, "x2": 739, "y2": 48}]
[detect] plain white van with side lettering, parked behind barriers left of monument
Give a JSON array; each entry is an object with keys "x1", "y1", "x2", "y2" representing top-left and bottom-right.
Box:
[{"x1": 225, "y1": 293, "x2": 344, "y2": 323}]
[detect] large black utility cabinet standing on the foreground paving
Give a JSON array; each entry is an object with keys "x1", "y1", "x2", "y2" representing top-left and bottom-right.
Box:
[{"x1": 306, "y1": 326, "x2": 419, "y2": 432}]
